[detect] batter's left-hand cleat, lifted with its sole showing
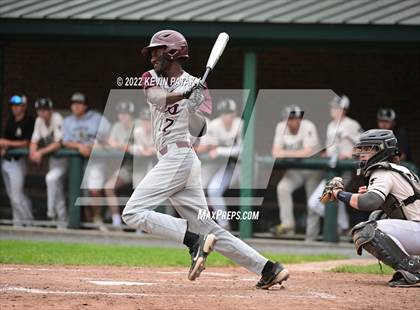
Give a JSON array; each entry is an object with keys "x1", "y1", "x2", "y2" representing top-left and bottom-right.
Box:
[{"x1": 188, "y1": 234, "x2": 216, "y2": 281}]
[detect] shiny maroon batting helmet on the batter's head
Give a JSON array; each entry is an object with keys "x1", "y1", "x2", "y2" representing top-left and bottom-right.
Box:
[{"x1": 141, "y1": 30, "x2": 189, "y2": 60}]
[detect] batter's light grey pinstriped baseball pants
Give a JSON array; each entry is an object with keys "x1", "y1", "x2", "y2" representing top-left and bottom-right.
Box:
[{"x1": 122, "y1": 144, "x2": 267, "y2": 274}]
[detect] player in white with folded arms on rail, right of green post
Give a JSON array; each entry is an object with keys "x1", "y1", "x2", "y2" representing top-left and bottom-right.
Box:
[{"x1": 270, "y1": 106, "x2": 320, "y2": 240}]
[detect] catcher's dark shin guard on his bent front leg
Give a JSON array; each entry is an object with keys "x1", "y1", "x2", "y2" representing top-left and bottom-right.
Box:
[{"x1": 352, "y1": 221, "x2": 420, "y2": 274}]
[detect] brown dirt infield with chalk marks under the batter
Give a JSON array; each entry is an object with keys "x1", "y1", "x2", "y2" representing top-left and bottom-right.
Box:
[{"x1": 0, "y1": 262, "x2": 420, "y2": 310}]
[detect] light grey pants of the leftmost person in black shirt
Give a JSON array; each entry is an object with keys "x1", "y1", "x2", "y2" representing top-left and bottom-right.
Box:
[{"x1": 1, "y1": 158, "x2": 33, "y2": 225}]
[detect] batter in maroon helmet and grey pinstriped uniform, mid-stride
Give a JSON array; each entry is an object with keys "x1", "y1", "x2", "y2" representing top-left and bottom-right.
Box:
[{"x1": 123, "y1": 30, "x2": 289, "y2": 288}]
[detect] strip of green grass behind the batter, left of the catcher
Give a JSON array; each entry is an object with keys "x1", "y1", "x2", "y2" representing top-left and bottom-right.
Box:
[{"x1": 0, "y1": 240, "x2": 347, "y2": 267}]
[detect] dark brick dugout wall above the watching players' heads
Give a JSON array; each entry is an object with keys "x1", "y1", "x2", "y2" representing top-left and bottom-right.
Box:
[{"x1": 0, "y1": 40, "x2": 420, "y2": 165}]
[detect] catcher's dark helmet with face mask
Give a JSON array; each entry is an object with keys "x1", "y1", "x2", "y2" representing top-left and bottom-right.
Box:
[{"x1": 353, "y1": 129, "x2": 399, "y2": 176}]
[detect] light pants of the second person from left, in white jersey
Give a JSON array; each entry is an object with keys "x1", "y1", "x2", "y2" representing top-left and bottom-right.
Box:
[{"x1": 45, "y1": 157, "x2": 67, "y2": 224}]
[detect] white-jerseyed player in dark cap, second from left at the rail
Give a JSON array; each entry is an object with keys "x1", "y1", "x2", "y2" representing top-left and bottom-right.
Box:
[{"x1": 29, "y1": 98, "x2": 67, "y2": 229}]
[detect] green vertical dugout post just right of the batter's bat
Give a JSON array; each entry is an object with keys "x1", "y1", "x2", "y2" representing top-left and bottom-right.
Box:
[{"x1": 239, "y1": 52, "x2": 257, "y2": 238}]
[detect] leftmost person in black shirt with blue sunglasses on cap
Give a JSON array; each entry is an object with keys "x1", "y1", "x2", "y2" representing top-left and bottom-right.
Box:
[{"x1": 0, "y1": 95, "x2": 35, "y2": 226}]
